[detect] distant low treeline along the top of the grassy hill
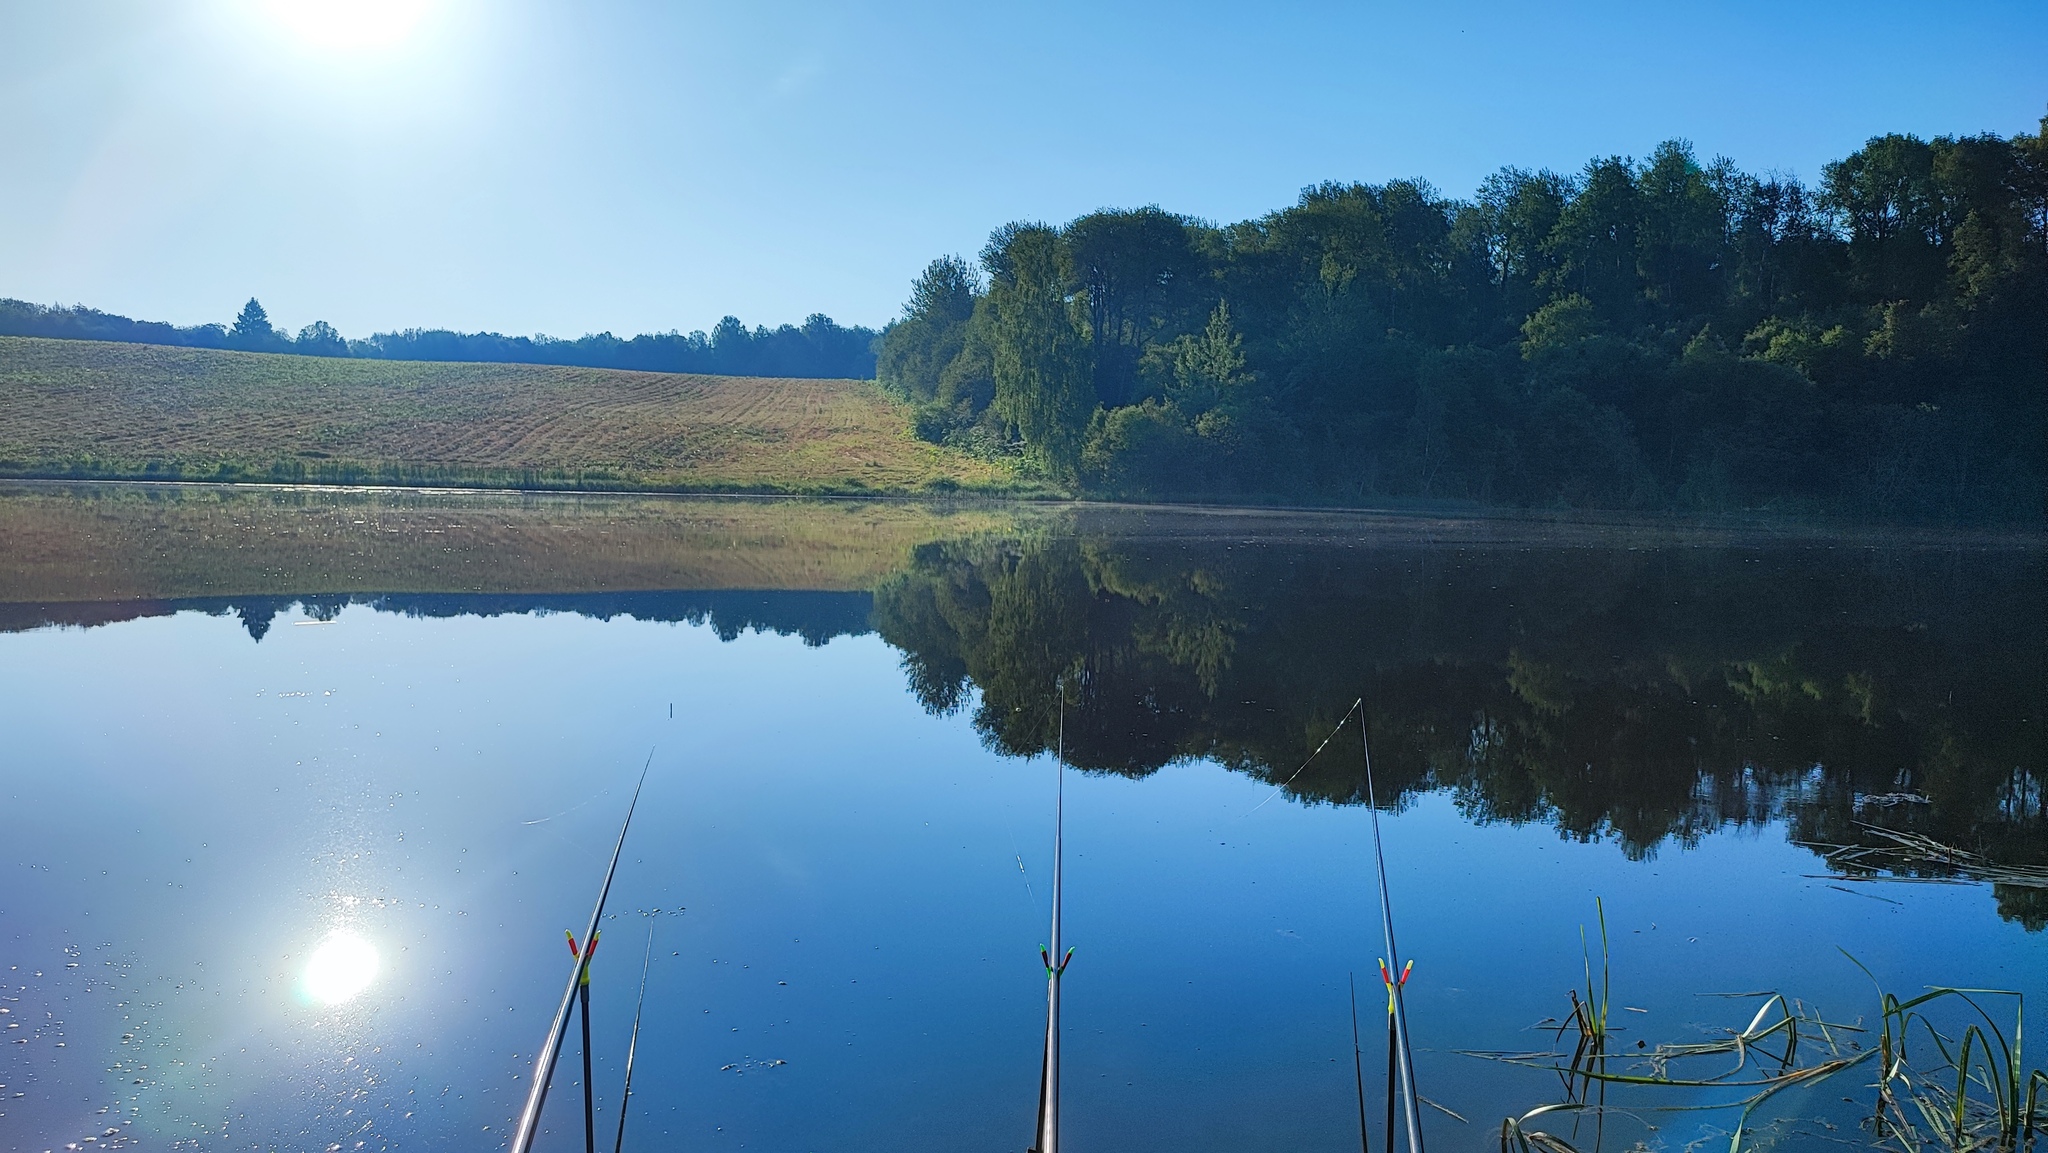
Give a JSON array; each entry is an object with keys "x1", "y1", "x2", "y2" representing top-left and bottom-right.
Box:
[{"x1": 0, "y1": 299, "x2": 874, "y2": 379}]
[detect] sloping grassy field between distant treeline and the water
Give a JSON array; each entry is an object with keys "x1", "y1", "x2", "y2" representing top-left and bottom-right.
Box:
[{"x1": 0, "y1": 338, "x2": 1018, "y2": 494}]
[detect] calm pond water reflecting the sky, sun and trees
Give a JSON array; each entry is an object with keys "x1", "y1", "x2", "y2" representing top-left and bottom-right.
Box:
[{"x1": 0, "y1": 485, "x2": 2048, "y2": 1153}]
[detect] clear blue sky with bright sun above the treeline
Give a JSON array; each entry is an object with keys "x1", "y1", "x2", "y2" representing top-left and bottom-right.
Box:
[{"x1": 0, "y1": 0, "x2": 2048, "y2": 336}]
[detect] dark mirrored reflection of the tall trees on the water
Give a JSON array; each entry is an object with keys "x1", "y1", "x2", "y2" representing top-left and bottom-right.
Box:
[{"x1": 874, "y1": 516, "x2": 2048, "y2": 930}]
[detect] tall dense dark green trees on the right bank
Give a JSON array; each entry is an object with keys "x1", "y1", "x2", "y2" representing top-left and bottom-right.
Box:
[{"x1": 879, "y1": 119, "x2": 2048, "y2": 520}]
